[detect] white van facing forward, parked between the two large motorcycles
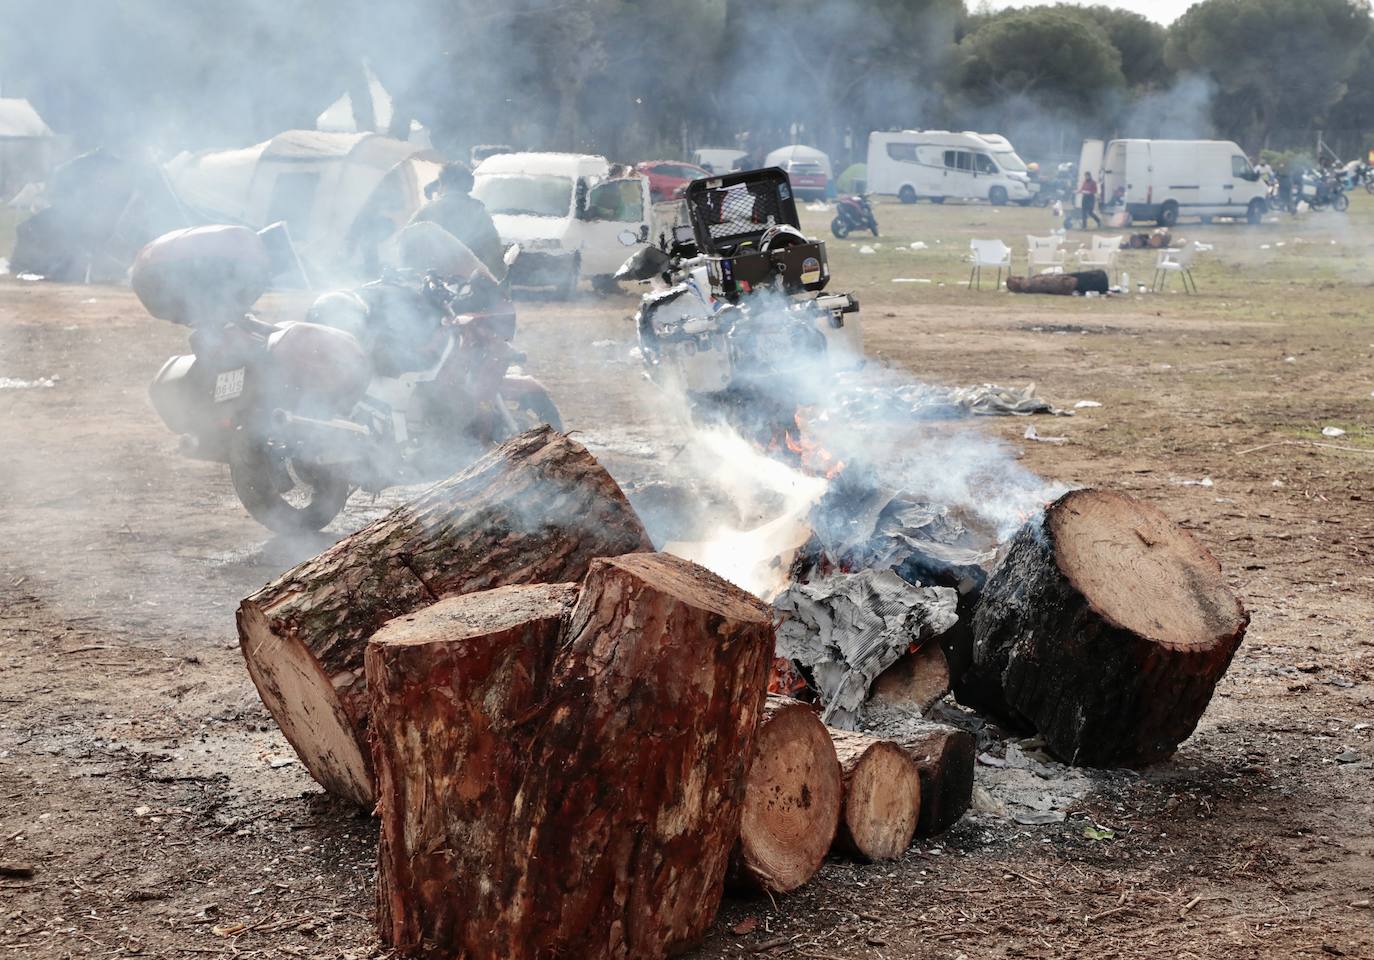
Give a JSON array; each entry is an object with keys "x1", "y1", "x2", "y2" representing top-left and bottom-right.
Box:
[{"x1": 473, "y1": 154, "x2": 651, "y2": 295}]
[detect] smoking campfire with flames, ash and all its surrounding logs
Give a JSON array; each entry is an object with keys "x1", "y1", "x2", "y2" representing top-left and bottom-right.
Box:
[{"x1": 239, "y1": 428, "x2": 1248, "y2": 960}]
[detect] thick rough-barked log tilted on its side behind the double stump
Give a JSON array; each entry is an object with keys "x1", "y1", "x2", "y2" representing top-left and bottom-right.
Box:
[{"x1": 238, "y1": 427, "x2": 651, "y2": 805}]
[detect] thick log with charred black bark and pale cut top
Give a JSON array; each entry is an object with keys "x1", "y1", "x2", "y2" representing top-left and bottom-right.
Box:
[{"x1": 973, "y1": 490, "x2": 1249, "y2": 766}]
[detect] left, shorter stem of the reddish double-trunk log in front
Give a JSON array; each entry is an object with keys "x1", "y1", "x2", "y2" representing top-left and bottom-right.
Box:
[{"x1": 365, "y1": 584, "x2": 577, "y2": 956}]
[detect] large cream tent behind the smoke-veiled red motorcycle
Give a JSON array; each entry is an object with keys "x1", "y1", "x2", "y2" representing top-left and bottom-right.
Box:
[{"x1": 166, "y1": 130, "x2": 441, "y2": 276}]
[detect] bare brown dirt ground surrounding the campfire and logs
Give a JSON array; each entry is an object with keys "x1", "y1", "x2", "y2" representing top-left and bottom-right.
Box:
[{"x1": 0, "y1": 196, "x2": 1374, "y2": 960}]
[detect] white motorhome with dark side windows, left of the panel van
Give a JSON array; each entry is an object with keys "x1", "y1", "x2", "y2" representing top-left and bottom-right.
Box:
[{"x1": 868, "y1": 130, "x2": 1036, "y2": 206}]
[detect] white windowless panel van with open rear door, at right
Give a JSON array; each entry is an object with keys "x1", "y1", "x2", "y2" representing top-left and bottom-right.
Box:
[{"x1": 1079, "y1": 140, "x2": 1268, "y2": 227}]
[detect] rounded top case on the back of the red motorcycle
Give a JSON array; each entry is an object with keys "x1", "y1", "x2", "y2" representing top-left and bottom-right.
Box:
[{"x1": 129, "y1": 225, "x2": 271, "y2": 327}]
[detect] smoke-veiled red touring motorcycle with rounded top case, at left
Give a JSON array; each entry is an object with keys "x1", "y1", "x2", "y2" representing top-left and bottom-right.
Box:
[{"x1": 131, "y1": 224, "x2": 561, "y2": 533}]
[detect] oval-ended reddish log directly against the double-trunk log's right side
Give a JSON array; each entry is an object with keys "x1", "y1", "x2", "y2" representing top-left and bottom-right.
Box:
[{"x1": 731, "y1": 695, "x2": 844, "y2": 893}]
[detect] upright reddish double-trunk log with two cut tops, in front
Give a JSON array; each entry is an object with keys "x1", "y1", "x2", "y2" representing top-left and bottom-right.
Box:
[{"x1": 367, "y1": 553, "x2": 774, "y2": 960}]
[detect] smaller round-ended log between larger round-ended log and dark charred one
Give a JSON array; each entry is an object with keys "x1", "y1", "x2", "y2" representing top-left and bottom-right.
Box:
[{"x1": 830, "y1": 729, "x2": 921, "y2": 860}]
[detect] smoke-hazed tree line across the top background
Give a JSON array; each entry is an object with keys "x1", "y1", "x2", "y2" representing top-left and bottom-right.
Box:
[{"x1": 0, "y1": 0, "x2": 1374, "y2": 162}]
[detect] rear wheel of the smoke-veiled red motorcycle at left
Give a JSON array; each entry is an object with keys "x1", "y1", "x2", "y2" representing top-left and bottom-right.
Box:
[{"x1": 229, "y1": 430, "x2": 349, "y2": 534}]
